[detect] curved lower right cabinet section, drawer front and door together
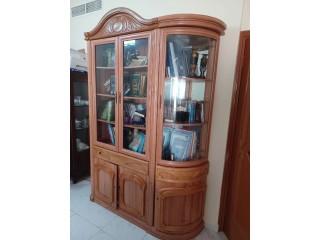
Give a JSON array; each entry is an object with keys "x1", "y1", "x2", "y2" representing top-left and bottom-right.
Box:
[{"x1": 154, "y1": 163, "x2": 208, "y2": 234}]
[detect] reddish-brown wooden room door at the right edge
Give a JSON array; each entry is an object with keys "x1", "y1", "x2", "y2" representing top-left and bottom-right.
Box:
[{"x1": 219, "y1": 31, "x2": 250, "y2": 240}]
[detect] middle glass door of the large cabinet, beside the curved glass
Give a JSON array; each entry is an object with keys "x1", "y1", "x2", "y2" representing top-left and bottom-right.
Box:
[{"x1": 119, "y1": 36, "x2": 149, "y2": 158}]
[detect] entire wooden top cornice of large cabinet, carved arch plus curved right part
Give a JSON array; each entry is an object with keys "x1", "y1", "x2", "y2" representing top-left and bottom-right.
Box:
[{"x1": 84, "y1": 8, "x2": 226, "y2": 40}]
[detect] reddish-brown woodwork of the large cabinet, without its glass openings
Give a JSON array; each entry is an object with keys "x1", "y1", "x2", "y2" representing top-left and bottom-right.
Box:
[{"x1": 85, "y1": 8, "x2": 226, "y2": 240}]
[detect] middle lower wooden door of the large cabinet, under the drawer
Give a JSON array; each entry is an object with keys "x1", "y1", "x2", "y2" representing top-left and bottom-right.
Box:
[{"x1": 119, "y1": 166, "x2": 150, "y2": 222}]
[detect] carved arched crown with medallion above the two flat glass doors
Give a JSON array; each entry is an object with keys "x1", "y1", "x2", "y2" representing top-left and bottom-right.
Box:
[{"x1": 84, "y1": 8, "x2": 158, "y2": 40}]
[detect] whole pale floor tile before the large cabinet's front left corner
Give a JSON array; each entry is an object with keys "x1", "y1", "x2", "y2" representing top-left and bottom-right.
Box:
[{"x1": 78, "y1": 203, "x2": 117, "y2": 228}]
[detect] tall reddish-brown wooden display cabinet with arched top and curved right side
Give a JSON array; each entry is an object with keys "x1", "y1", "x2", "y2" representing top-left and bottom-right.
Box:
[{"x1": 85, "y1": 8, "x2": 226, "y2": 239}]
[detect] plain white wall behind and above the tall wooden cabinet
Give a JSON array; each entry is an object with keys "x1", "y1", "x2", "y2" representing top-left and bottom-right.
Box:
[{"x1": 70, "y1": 0, "x2": 249, "y2": 231}]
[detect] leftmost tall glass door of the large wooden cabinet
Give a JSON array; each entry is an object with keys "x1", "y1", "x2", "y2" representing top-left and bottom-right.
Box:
[{"x1": 94, "y1": 42, "x2": 117, "y2": 147}]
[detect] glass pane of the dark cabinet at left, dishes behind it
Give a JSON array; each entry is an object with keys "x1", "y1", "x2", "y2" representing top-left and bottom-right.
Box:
[{"x1": 73, "y1": 80, "x2": 90, "y2": 152}]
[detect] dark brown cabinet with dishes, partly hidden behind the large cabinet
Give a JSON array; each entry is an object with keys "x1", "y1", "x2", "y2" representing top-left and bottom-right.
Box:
[{"x1": 70, "y1": 71, "x2": 90, "y2": 183}]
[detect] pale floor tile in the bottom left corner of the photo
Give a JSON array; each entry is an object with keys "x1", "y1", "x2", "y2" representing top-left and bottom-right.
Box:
[{"x1": 70, "y1": 214, "x2": 99, "y2": 240}]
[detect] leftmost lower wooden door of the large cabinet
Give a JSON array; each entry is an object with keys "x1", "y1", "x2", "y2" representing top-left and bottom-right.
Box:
[{"x1": 94, "y1": 157, "x2": 117, "y2": 208}]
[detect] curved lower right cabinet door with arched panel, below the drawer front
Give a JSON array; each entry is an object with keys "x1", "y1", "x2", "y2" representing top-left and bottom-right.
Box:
[{"x1": 155, "y1": 185, "x2": 206, "y2": 233}]
